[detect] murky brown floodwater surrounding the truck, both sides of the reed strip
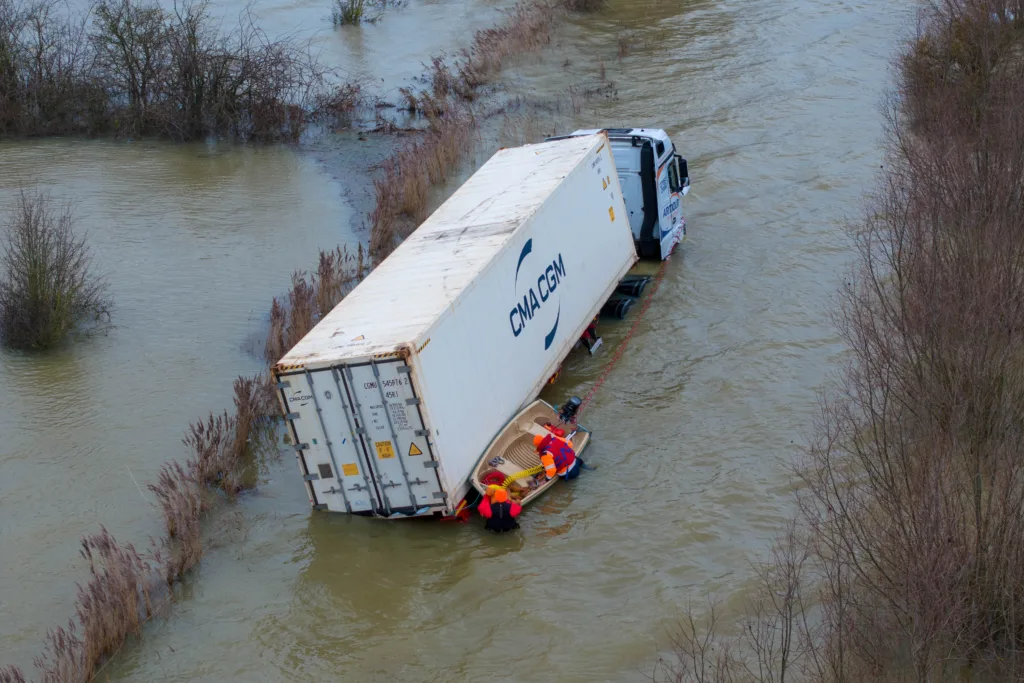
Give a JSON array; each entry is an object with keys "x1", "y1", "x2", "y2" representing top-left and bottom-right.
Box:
[{"x1": 0, "y1": 0, "x2": 912, "y2": 682}]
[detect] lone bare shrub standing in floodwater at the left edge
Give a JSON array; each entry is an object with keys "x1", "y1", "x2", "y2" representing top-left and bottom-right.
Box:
[{"x1": 0, "y1": 190, "x2": 108, "y2": 349}]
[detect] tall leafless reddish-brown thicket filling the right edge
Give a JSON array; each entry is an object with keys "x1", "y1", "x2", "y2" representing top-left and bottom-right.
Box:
[{"x1": 659, "y1": 0, "x2": 1024, "y2": 681}]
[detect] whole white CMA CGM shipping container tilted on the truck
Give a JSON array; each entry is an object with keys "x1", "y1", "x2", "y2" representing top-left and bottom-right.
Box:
[{"x1": 274, "y1": 133, "x2": 637, "y2": 516}]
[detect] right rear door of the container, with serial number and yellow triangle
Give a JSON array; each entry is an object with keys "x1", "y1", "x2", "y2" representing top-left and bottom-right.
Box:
[{"x1": 344, "y1": 358, "x2": 447, "y2": 515}]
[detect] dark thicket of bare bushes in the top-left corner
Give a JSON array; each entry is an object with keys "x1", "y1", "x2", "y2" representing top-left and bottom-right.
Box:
[{"x1": 0, "y1": 0, "x2": 359, "y2": 140}]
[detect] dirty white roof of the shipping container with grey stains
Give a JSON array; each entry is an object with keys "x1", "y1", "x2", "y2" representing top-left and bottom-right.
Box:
[{"x1": 278, "y1": 134, "x2": 606, "y2": 370}]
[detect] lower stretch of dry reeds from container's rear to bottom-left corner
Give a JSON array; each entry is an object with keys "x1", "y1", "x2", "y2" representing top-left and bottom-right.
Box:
[{"x1": 0, "y1": 374, "x2": 276, "y2": 683}]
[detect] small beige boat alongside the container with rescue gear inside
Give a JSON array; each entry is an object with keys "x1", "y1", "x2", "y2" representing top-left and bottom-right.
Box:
[{"x1": 471, "y1": 398, "x2": 591, "y2": 505}]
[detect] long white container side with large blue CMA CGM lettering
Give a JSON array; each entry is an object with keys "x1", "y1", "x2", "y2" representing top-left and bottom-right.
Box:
[{"x1": 405, "y1": 136, "x2": 636, "y2": 492}]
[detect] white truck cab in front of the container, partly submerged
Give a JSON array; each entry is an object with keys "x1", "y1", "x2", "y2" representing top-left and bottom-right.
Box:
[{"x1": 548, "y1": 128, "x2": 690, "y2": 259}]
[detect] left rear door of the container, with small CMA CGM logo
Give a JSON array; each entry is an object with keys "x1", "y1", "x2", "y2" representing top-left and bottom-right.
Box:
[{"x1": 282, "y1": 370, "x2": 382, "y2": 513}]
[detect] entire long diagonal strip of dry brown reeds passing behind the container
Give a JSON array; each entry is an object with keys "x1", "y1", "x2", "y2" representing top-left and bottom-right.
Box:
[{"x1": 0, "y1": 0, "x2": 594, "y2": 683}]
